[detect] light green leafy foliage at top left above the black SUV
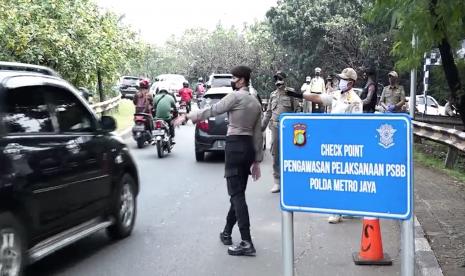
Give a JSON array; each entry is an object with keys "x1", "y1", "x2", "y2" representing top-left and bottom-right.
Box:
[{"x1": 0, "y1": 0, "x2": 141, "y2": 96}]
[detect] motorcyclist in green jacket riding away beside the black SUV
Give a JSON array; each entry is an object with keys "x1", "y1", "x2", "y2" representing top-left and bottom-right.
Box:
[{"x1": 153, "y1": 88, "x2": 178, "y2": 140}]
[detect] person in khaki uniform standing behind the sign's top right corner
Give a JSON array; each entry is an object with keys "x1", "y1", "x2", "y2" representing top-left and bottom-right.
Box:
[{"x1": 379, "y1": 71, "x2": 405, "y2": 113}]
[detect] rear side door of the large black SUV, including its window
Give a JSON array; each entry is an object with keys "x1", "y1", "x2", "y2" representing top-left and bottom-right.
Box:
[{"x1": 0, "y1": 86, "x2": 71, "y2": 236}]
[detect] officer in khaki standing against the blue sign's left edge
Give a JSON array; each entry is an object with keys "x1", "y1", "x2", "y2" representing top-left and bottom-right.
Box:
[{"x1": 262, "y1": 71, "x2": 299, "y2": 193}]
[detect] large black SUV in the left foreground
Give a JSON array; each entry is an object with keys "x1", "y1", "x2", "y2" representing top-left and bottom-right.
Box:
[{"x1": 0, "y1": 62, "x2": 139, "y2": 275}]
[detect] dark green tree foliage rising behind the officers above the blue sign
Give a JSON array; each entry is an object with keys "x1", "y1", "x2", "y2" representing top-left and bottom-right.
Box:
[{"x1": 267, "y1": 0, "x2": 392, "y2": 86}]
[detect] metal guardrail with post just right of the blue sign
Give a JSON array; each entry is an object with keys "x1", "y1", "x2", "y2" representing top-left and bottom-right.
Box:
[{"x1": 412, "y1": 121, "x2": 465, "y2": 169}]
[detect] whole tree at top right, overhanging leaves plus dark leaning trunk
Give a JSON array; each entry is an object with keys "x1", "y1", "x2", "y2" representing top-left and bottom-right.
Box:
[{"x1": 367, "y1": 0, "x2": 465, "y2": 126}]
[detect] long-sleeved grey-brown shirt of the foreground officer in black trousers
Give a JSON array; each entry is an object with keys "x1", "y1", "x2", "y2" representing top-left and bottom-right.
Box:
[{"x1": 187, "y1": 87, "x2": 263, "y2": 162}]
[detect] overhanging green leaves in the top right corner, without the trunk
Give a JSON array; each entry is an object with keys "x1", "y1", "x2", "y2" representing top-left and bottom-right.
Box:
[{"x1": 366, "y1": 0, "x2": 465, "y2": 71}]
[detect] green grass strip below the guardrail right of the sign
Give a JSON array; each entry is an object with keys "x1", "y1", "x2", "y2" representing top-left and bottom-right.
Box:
[{"x1": 413, "y1": 141, "x2": 465, "y2": 183}]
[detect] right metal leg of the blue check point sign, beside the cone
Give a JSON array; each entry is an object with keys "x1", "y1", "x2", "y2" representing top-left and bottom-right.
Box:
[{"x1": 400, "y1": 215, "x2": 415, "y2": 276}]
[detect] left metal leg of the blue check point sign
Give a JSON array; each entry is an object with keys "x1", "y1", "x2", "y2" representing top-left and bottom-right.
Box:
[{"x1": 281, "y1": 211, "x2": 294, "y2": 276}]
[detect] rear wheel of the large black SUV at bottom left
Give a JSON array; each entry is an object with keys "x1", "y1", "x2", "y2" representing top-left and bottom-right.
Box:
[{"x1": 0, "y1": 213, "x2": 26, "y2": 276}]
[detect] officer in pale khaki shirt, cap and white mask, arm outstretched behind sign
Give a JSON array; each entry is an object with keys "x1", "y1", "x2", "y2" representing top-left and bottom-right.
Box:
[{"x1": 288, "y1": 68, "x2": 363, "y2": 223}]
